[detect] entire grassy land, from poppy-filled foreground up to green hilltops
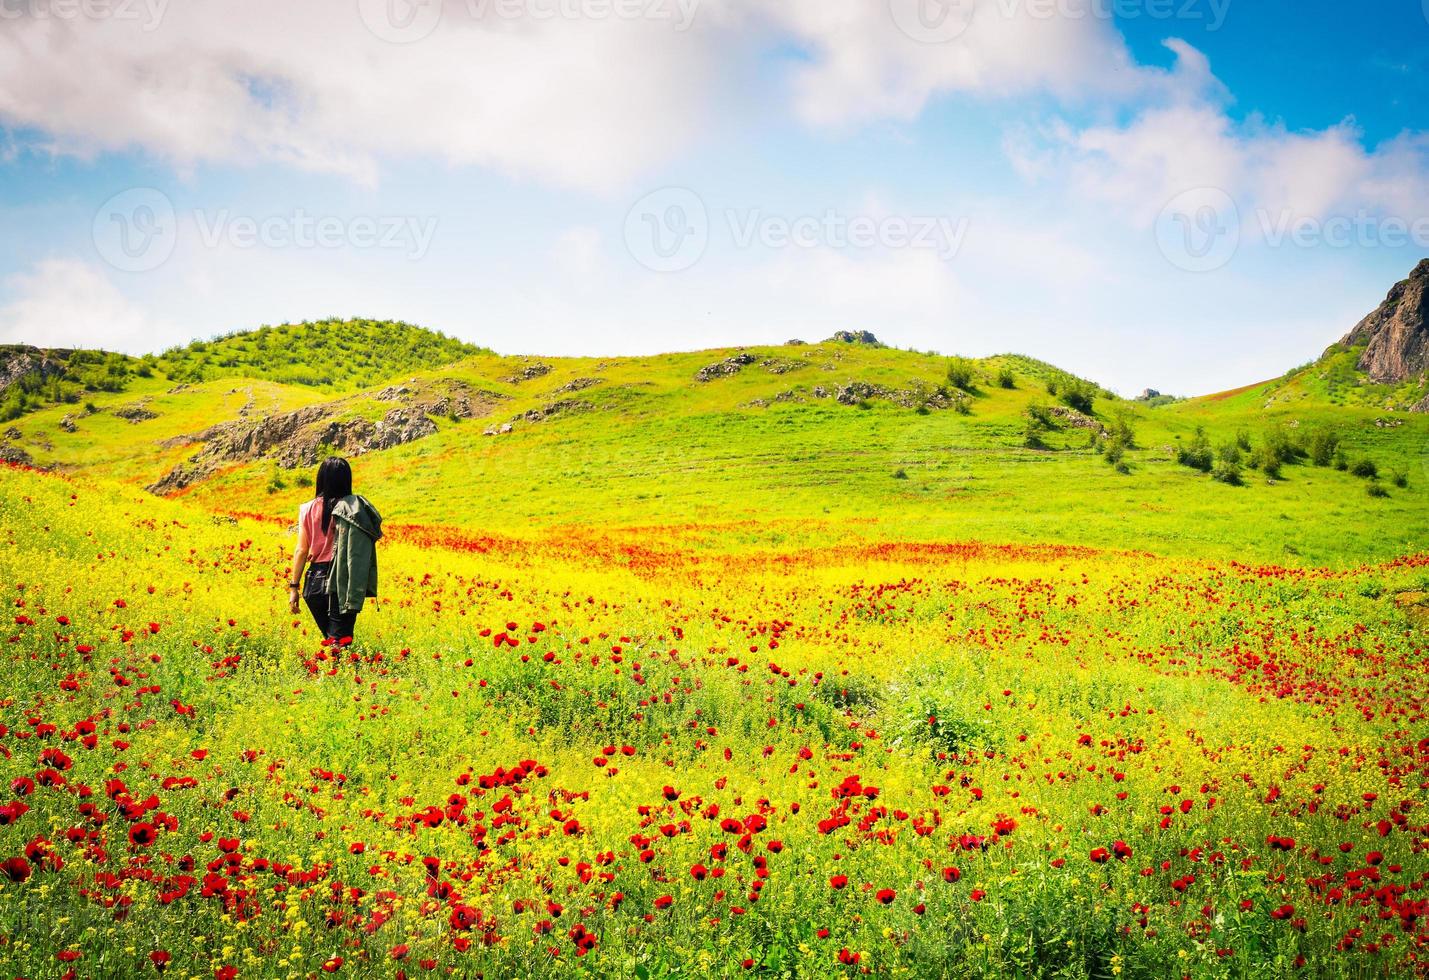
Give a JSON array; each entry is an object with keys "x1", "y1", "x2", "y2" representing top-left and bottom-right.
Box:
[{"x1": 0, "y1": 324, "x2": 1429, "y2": 980}]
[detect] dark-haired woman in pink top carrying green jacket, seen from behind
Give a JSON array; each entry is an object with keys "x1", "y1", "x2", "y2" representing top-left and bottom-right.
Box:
[{"x1": 287, "y1": 456, "x2": 382, "y2": 644}]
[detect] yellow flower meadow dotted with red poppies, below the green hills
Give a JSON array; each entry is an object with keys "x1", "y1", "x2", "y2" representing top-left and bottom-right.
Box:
[{"x1": 0, "y1": 469, "x2": 1429, "y2": 980}]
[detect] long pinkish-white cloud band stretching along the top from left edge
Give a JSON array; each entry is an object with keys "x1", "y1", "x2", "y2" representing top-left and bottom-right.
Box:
[{"x1": 0, "y1": 0, "x2": 1240, "y2": 190}]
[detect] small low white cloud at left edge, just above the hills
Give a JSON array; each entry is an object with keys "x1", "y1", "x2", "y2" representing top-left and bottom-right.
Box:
[{"x1": 0, "y1": 259, "x2": 166, "y2": 353}]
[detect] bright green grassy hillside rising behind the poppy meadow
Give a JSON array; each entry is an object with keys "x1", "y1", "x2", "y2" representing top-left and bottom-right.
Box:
[{"x1": 7, "y1": 327, "x2": 1429, "y2": 564}]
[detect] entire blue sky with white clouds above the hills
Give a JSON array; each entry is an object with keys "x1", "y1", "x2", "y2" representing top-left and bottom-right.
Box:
[{"x1": 0, "y1": 0, "x2": 1429, "y2": 393}]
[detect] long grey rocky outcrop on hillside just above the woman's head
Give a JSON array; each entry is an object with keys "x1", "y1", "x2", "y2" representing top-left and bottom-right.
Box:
[{"x1": 147, "y1": 381, "x2": 496, "y2": 494}]
